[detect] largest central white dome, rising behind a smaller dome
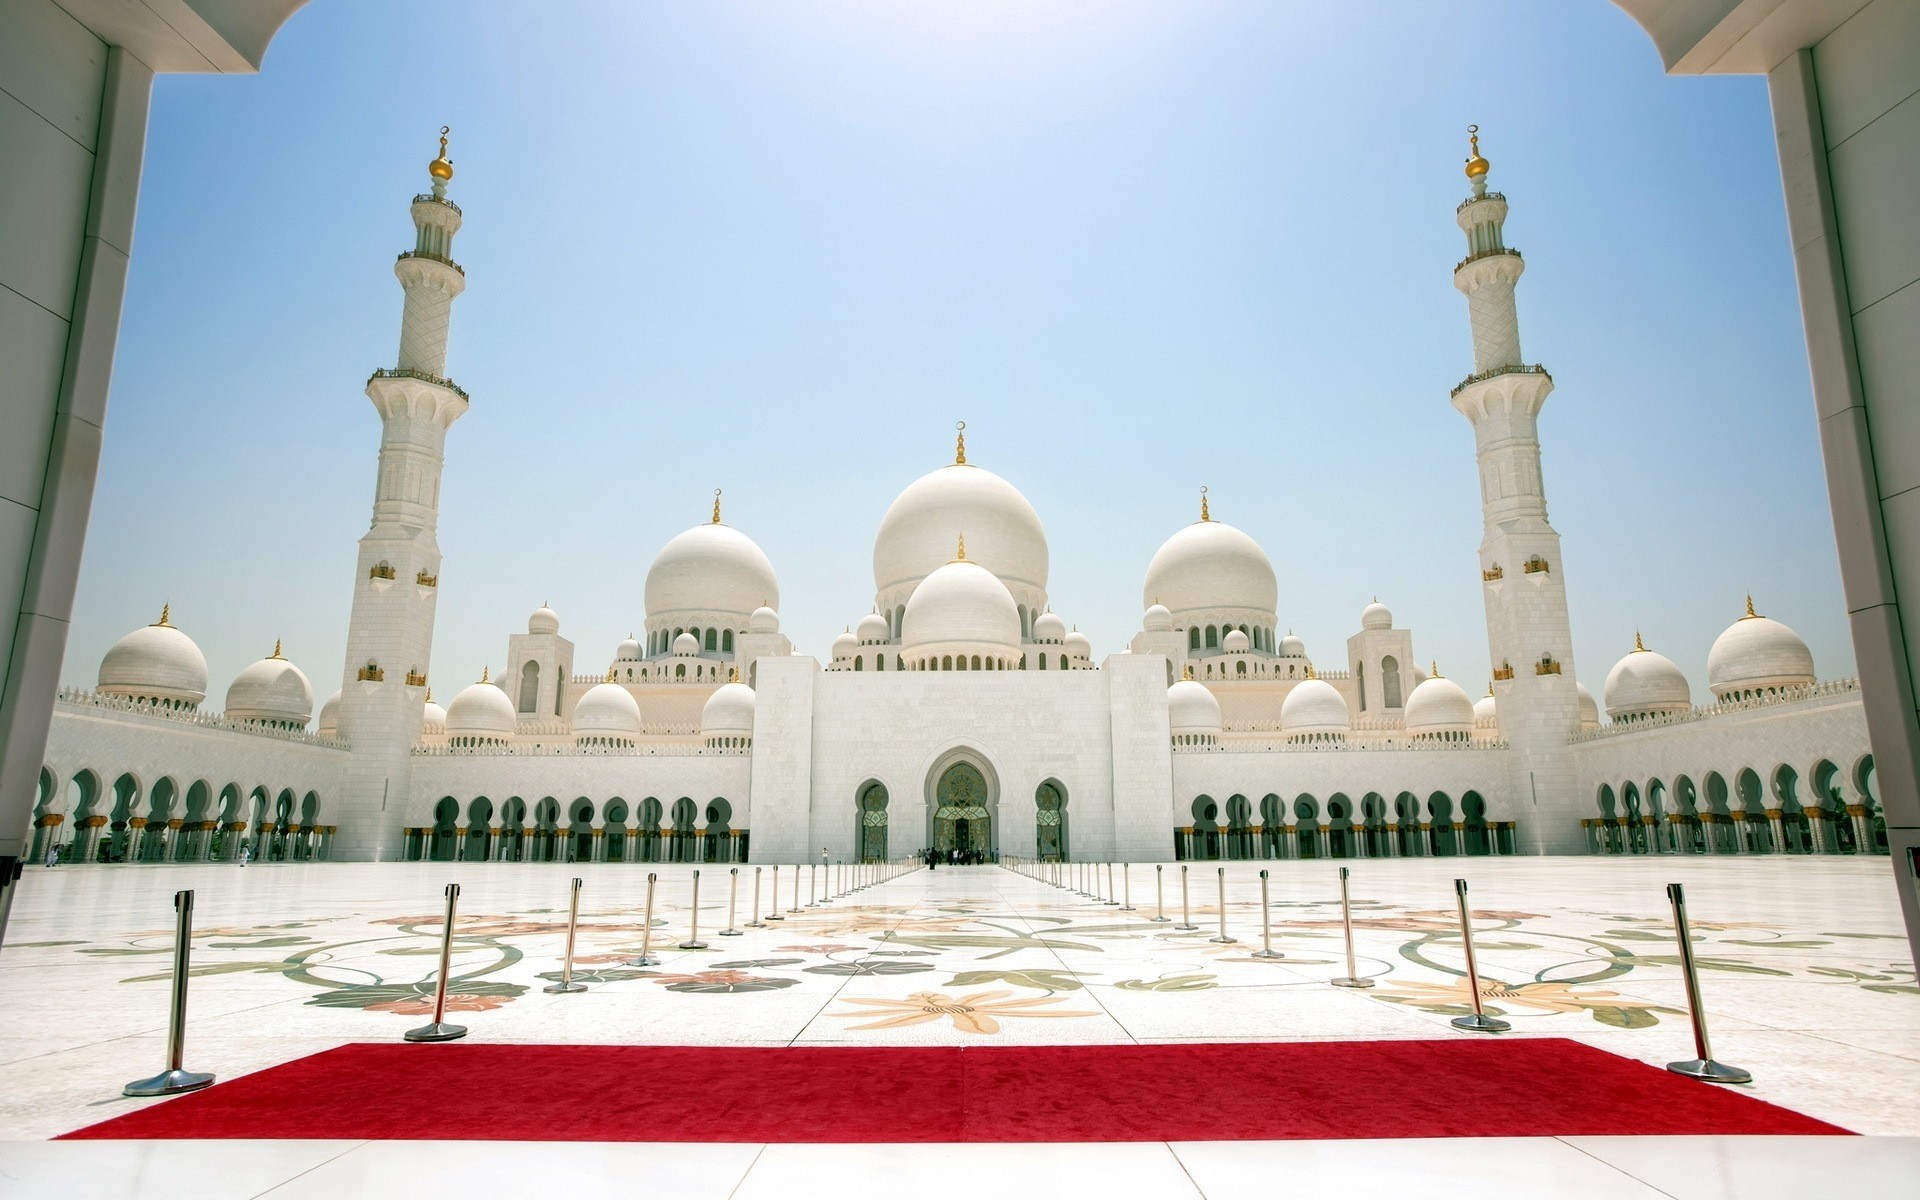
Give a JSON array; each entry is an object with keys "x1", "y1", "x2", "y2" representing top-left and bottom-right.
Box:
[{"x1": 874, "y1": 463, "x2": 1046, "y2": 593}]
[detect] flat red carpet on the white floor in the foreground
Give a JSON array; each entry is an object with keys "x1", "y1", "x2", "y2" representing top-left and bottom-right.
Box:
[{"x1": 65, "y1": 1037, "x2": 1847, "y2": 1142}]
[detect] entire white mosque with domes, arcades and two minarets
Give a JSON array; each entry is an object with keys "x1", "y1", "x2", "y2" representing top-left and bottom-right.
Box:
[{"x1": 22, "y1": 128, "x2": 1887, "y2": 862}]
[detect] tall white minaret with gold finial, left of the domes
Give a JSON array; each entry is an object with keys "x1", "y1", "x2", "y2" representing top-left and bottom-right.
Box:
[{"x1": 332, "y1": 127, "x2": 467, "y2": 858}]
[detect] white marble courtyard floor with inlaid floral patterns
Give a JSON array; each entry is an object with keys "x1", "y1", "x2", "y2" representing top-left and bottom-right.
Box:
[{"x1": 0, "y1": 858, "x2": 1920, "y2": 1200}]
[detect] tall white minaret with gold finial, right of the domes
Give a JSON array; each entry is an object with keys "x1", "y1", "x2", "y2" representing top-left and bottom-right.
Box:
[{"x1": 1453, "y1": 125, "x2": 1584, "y2": 854}]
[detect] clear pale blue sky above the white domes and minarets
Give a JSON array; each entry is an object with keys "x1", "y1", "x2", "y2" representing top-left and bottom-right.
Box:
[{"x1": 65, "y1": 0, "x2": 1853, "y2": 708}]
